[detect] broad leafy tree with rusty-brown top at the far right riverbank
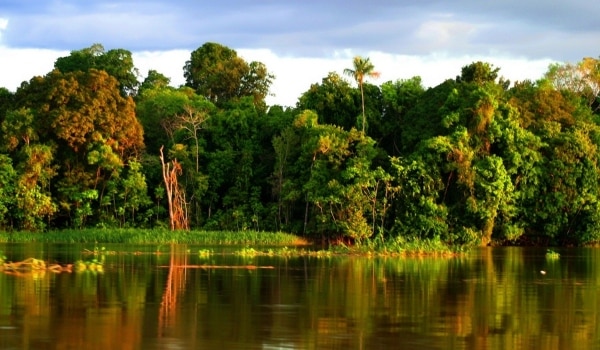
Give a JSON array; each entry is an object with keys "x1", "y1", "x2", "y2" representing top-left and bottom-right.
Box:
[{"x1": 510, "y1": 81, "x2": 600, "y2": 244}]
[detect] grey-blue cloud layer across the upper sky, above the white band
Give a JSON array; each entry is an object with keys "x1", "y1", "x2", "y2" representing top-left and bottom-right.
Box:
[{"x1": 0, "y1": 0, "x2": 600, "y2": 60}]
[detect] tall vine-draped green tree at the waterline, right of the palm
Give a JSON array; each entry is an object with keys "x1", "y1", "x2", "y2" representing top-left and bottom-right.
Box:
[{"x1": 393, "y1": 63, "x2": 515, "y2": 245}]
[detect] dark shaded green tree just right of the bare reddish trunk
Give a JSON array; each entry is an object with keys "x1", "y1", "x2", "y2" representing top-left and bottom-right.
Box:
[{"x1": 203, "y1": 97, "x2": 264, "y2": 229}]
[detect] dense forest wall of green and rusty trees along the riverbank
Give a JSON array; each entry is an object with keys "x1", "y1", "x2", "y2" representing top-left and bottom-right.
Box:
[{"x1": 0, "y1": 43, "x2": 600, "y2": 245}]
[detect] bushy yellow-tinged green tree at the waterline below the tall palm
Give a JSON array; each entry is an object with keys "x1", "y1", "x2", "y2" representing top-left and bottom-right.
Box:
[{"x1": 272, "y1": 111, "x2": 391, "y2": 242}]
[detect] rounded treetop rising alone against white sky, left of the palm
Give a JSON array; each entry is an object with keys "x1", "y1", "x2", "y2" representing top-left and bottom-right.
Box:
[{"x1": 183, "y1": 42, "x2": 275, "y2": 106}]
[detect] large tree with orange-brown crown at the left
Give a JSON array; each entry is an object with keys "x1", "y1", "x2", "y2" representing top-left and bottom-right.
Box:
[{"x1": 12, "y1": 68, "x2": 144, "y2": 226}]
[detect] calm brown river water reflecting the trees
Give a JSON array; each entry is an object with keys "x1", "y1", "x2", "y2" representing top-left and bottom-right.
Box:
[{"x1": 0, "y1": 244, "x2": 600, "y2": 350}]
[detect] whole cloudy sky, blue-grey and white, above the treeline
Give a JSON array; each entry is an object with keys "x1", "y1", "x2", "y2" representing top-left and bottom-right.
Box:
[{"x1": 0, "y1": 0, "x2": 600, "y2": 106}]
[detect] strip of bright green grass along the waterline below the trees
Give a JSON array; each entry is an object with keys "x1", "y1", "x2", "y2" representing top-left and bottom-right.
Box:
[{"x1": 0, "y1": 228, "x2": 458, "y2": 257}]
